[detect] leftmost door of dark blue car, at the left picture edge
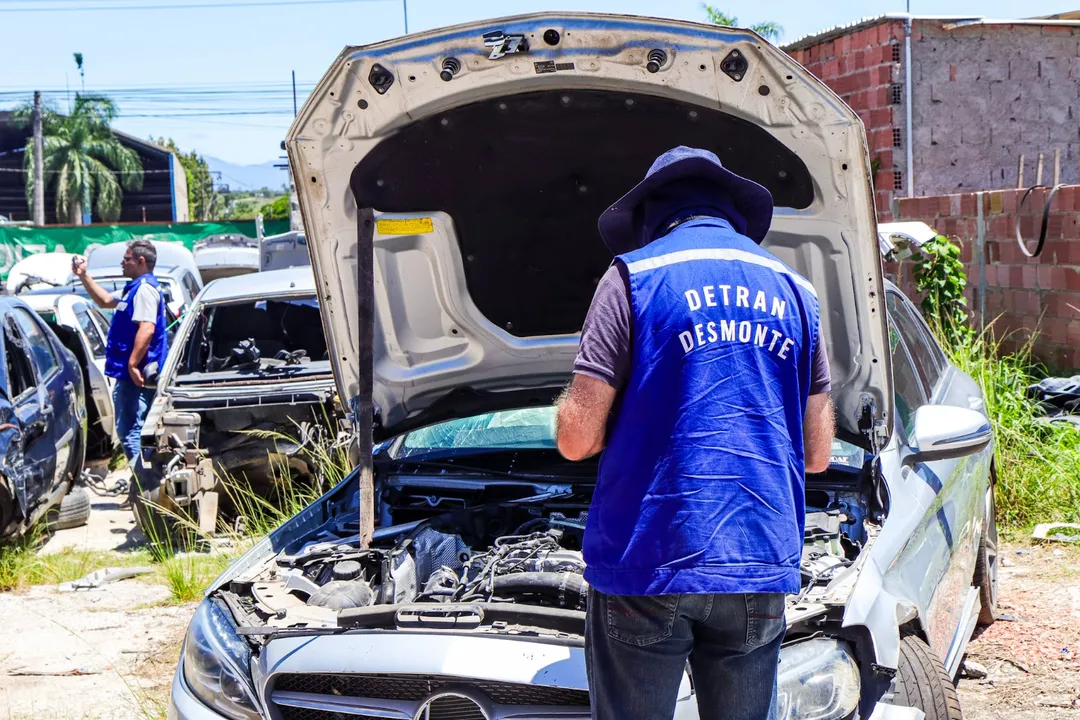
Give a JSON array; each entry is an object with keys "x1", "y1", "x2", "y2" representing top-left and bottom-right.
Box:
[{"x1": 2, "y1": 314, "x2": 56, "y2": 517}]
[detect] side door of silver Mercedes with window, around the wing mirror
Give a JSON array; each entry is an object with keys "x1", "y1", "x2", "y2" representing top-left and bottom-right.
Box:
[{"x1": 887, "y1": 290, "x2": 993, "y2": 662}]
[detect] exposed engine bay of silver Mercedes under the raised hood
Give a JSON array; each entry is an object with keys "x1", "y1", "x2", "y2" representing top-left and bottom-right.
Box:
[{"x1": 212, "y1": 453, "x2": 882, "y2": 636}]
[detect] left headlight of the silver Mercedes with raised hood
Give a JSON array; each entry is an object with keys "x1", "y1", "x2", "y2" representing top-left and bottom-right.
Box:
[{"x1": 184, "y1": 599, "x2": 259, "y2": 720}]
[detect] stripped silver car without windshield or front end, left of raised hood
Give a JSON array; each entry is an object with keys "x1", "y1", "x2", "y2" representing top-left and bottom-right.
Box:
[{"x1": 136, "y1": 267, "x2": 336, "y2": 531}]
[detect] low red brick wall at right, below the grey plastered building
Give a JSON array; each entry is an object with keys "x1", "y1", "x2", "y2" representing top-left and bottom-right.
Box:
[{"x1": 886, "y1": 186, "x2": 1080, "y2": 370}]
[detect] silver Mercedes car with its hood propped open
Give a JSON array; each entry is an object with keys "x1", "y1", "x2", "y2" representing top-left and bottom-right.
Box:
[{"x1": 171, "y1": 14, "x2": 997, "y2": 720}]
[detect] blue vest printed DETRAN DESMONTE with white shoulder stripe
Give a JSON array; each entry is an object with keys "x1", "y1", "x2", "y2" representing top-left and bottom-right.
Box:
[{"x1": 584, "y1": 218, "x2": 819, "y2": 595}]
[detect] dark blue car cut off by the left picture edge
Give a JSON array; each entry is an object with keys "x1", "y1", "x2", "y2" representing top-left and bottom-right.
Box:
[{"x1": 0, "y1": 298, "x2": 90, "y2": 536}]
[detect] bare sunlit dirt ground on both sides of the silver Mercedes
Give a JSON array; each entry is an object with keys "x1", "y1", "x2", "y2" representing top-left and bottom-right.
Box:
[{"x1": 0, "y1": 481, "x2": 1080, "y2": 720}]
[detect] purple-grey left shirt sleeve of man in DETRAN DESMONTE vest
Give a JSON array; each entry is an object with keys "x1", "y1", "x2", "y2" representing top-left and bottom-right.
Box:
[{"x1": 573, "y1": 261, "x2": 631, "y2": 390}]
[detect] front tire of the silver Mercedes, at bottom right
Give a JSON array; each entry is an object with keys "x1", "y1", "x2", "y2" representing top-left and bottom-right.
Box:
[{"x1": 891, "y1": 635, "x2": 963, "y2": 720}]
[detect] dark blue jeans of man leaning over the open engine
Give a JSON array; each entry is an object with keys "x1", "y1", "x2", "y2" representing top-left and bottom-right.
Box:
[{"x1": 585, "y1": 590, "x2": 785, "y2": 720}]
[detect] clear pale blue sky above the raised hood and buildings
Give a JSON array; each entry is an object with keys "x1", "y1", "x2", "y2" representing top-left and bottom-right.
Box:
[{"x1": 0, "y1": 0, "x2": 1080, "y2": 165}]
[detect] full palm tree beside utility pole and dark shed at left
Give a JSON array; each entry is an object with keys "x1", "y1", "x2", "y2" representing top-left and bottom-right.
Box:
[{"x1": 19, "y1": 95, "x2": 143, "y2": 225}]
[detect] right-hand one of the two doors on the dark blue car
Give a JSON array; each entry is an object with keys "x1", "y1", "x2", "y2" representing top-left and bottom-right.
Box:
[{"x1": 11, "y1": 307, "x2": 76, "y2": 488}]
